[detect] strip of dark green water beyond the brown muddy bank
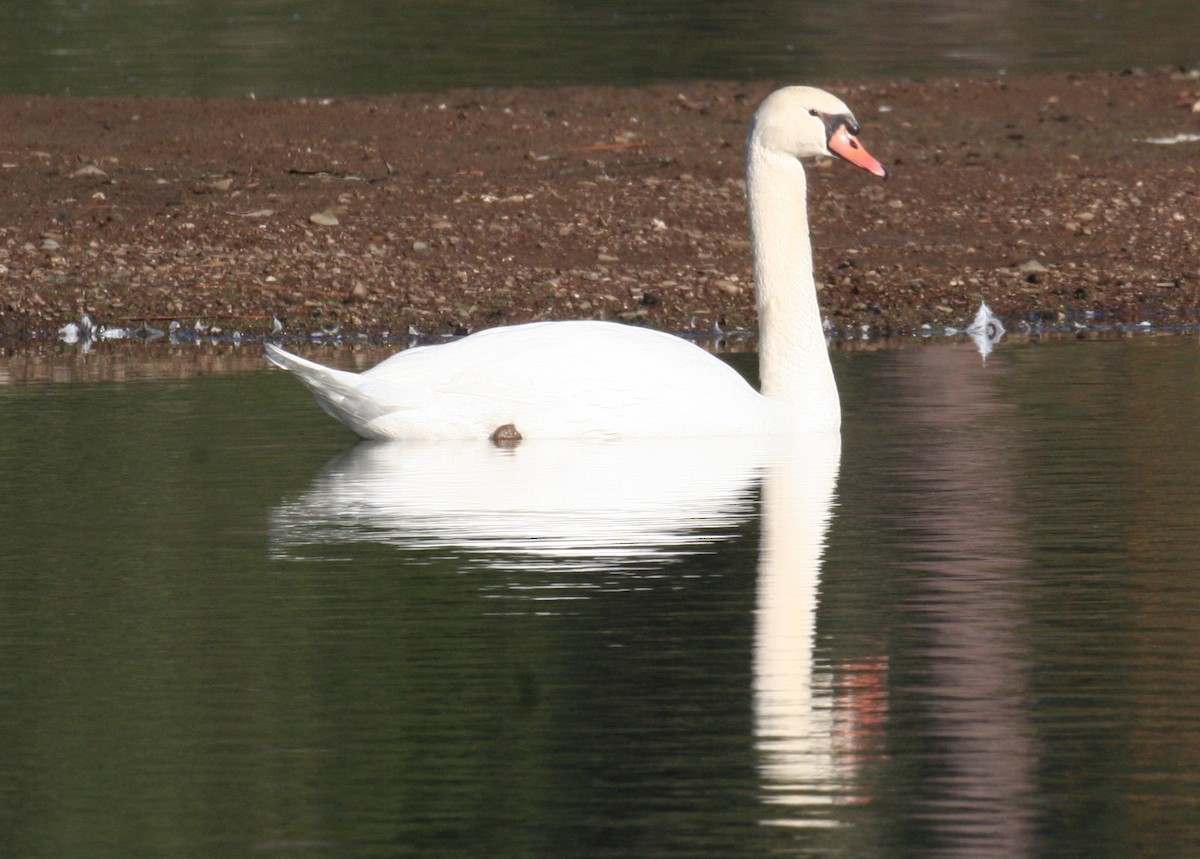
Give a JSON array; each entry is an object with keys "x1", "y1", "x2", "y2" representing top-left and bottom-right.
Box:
[{"x1": 0, "y1": 0, "x2": 1200, "y2": 97}]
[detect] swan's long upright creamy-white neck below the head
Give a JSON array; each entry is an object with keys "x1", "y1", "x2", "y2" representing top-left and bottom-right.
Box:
[{"x1": 746, "y1": 144, "x2": 841, "y2": 431}]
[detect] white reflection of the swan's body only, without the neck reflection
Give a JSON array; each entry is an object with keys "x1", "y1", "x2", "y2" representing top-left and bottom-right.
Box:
[{"x1": 272, "y1": 439, "x2": 761, "y2": 572}]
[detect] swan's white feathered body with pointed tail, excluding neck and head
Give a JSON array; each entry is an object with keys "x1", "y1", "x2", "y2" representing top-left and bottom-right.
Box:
[{"x1": 270, "y1": 320, "x2": 772, "y2": 439}]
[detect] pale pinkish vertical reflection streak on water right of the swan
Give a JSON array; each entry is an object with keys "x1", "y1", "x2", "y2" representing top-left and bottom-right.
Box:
[{"x1": 896, "y1": 340, "x2": 1040, "y2": 857}]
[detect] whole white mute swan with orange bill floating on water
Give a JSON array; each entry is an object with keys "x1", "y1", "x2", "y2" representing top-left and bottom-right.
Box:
[{"x1": 266, "y1": 86, "x2": 887, "y2": 440}]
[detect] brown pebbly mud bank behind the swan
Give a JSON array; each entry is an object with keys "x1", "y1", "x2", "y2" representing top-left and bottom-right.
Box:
[{"x1": 0, "y1": 71, "x2": 1200, "y2": 350}]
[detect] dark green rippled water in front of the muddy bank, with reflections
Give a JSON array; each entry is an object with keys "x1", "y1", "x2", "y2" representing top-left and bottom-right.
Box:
[{"x1": 0, "y1": 335, "x2": 1200, "y2": 859}]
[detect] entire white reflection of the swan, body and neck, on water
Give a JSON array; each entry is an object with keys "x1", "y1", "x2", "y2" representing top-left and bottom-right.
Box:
[{"x1": 271, "y1": 433, "x2": 856, "y2": 825}]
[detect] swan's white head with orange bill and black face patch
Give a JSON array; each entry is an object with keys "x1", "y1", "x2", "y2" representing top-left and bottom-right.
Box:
[{"x1": 748, "y1": 86, "x2": 888, "y2": 179}]
